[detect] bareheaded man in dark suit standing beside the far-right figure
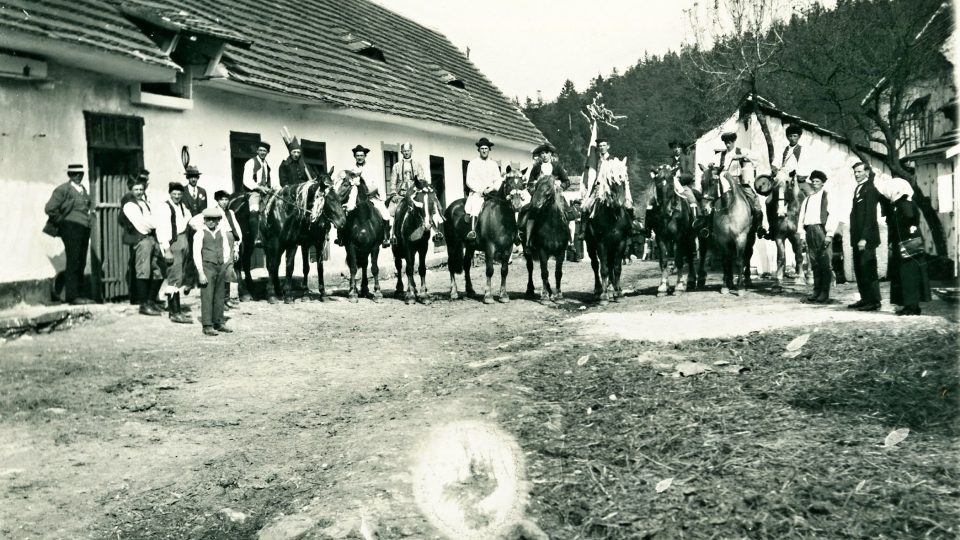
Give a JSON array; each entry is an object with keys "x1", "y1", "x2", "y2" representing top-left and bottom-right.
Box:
[{"x1": 847, "y1": 162, "x2": 880, "y2": 311}]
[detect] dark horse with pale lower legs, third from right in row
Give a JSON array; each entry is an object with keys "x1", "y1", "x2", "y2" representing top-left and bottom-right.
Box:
[{"x1": 650, "y1": 165, "x2": 706, "y2": 297}]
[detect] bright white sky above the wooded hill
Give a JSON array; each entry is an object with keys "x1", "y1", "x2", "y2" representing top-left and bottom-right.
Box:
[{"x1": 374, "y1": 0, "x2": 694, "y2": 103}]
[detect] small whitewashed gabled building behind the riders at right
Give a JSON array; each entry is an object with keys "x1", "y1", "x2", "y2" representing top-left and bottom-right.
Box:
[{"x1": 695, "y1": 97, "x2": 890, "y2": 279}]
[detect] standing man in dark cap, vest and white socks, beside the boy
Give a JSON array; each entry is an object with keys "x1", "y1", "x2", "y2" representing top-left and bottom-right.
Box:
[{"x1": 155, "y1": 182, "x2": 193, "y2": 324}]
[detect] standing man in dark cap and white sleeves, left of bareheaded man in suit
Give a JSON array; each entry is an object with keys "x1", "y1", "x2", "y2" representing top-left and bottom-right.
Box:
[{"x1": 797, "y1": 171, "x2": 839, "y2": 304}]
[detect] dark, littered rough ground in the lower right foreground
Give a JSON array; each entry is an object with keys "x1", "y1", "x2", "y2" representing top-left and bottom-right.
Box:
[{"x1": 502, "y1": 323, "x2": 960, "y2": 538}]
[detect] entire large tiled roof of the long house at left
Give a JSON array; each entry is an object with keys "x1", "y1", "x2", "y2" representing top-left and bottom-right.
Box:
[{"x1": 0, "y1": 0, "x2": 545, "y2": 145}]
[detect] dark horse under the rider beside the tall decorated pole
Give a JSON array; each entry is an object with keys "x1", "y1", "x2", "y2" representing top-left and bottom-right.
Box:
[{"x1": 583, "y1": 159, "x2": 633, "y2": 305}]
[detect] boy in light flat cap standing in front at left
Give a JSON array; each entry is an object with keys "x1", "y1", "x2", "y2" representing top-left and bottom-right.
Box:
[{"x1": 193, "y1": 207, "x2": 233, "y2": 336}]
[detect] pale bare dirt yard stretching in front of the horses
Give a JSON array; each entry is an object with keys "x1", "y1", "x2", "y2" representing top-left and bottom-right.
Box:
[{"x1": 0, "y1": 263, "x2": 955, "y2": 538}]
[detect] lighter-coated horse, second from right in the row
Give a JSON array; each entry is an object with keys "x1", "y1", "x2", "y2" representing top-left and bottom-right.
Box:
[{"x1": 700, "y1": 165, "x2": 759, "y2": 294}]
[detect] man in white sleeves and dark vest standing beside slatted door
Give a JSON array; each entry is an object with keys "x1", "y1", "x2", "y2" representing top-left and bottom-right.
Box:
[{"x1": 120, "y1": 175, "x2": 163, "y2": 316}]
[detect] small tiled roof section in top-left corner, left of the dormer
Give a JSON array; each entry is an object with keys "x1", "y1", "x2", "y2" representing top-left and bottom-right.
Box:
[{"x1": 0, "y1": 0, "x2": 180, "y2": 71}]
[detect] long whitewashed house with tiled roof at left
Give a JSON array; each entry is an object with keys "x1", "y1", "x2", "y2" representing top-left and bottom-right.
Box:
[{"x1": 0, "y1": 0, "x2": 545, "y2": 306}]
